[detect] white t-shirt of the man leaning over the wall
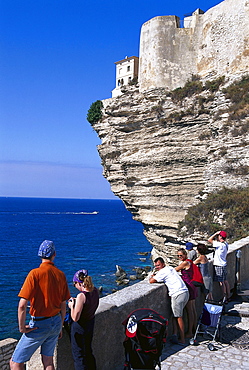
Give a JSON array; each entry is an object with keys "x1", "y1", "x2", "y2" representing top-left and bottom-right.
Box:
[{"x1": 153, "y1": 266, "x2": 188, "y2": 297}]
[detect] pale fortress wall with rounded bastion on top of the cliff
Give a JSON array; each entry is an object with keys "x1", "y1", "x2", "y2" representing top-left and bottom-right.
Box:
[{"x1": 139, "y1": 0, "x2": 249, "y2": 92}]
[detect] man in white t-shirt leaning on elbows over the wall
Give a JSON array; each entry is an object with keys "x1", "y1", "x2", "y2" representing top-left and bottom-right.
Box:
[{"x1": 149, "y1": 257, "x2": 189, "y2": 345}]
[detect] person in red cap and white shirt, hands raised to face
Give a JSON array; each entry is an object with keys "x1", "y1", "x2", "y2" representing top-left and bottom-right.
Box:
[{"x1": 208, "y1": 231, "x2": 230, "y2": 303}]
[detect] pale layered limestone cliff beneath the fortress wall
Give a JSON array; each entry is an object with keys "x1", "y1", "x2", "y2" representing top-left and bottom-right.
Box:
[{"x1": 93, "y1": 87, "x2": 249, "y2": 262}]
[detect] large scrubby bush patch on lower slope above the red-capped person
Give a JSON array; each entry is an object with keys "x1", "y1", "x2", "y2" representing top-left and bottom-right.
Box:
[{"x1": 178, "y1": 187, "x2": 249, "y2": 242}]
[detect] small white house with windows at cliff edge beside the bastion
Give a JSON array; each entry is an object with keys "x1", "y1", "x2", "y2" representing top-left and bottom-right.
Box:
[{"x1": 112, "y1": 56, "x2": 139, "y2": 98}]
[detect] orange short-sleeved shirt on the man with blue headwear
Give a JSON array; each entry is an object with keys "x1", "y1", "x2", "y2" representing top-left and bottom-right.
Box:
[{"x1": 18, "y1": 260, "x2": 70, "y2": 317}]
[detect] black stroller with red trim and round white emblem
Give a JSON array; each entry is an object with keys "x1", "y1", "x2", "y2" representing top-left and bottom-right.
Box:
[{"x1": 122, "y1": 308, "x2": 168, "y2": 370}]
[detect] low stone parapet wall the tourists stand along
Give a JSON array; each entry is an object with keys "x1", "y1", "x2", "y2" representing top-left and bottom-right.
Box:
[{"x1": 0, "y1": 236, "x2": 249, "y2": 370}]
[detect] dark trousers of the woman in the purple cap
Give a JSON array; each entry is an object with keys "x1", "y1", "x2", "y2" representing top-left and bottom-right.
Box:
[{"x1": 71, "y1": 318, "x2": 96, "y2": 370}]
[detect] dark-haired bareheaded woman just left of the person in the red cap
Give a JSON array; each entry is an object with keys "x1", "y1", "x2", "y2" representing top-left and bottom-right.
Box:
[{"x1": 193, "y1": 243, "x2": 213, "y2": 300}]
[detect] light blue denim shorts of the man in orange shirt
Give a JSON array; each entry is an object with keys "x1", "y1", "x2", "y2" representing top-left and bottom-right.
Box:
[{"x1": 12, "y1": 314, "x2": 62, "y2": 363}]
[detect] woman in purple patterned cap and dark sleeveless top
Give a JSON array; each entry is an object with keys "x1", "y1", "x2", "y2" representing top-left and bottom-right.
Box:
[{"x1": 68, "y1": 270, "x2": 99, "y2": 370}]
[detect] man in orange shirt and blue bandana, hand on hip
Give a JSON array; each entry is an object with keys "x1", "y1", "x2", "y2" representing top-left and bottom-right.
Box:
[{"x1": 10, "y1": 240, "x2": 70, "y2": 370}]
